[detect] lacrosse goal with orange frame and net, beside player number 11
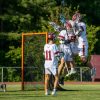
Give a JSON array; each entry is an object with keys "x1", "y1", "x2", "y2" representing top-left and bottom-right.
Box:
[{"x1": 22, "y1": 32, "x2": 47, "y2": 90}]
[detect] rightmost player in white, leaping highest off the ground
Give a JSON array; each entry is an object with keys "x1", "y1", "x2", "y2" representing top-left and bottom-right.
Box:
[{"x1": 72, "y1": 13, "x2": 88, "y2": 62}]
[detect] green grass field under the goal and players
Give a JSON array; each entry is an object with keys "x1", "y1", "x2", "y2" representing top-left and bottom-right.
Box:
[{"x1": 0, "y1": 84, "x2": 100, "y2": 100}]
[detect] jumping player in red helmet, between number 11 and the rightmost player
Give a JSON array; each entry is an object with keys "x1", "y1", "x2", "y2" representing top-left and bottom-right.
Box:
[{"x1": 58, "y1": 22, "x2": 75, "y2": 81}]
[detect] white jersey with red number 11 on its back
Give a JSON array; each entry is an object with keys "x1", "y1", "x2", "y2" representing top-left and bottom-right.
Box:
[{"x1": 44, "y1": 44, "x2": 59, "y2": 68}]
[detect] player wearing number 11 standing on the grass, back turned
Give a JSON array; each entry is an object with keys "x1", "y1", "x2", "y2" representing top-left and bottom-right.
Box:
[{"x1": 44, "y1": 33, "x2": 59, "y2": 95}]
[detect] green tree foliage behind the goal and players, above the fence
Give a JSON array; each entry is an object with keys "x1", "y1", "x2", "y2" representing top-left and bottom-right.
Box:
[{"x1": 0, "y1": 0, "x2": 100, "y2": 81}]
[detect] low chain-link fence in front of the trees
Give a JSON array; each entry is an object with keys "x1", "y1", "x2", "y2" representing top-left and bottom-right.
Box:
[{"x1": 0, "y1": 67, "x2": 92, "y2": 82}]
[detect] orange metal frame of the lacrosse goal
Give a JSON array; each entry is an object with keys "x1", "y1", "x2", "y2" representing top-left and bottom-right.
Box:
[{"x1": 21, "y1": 32, "x2": 48, "y2": 90}]
